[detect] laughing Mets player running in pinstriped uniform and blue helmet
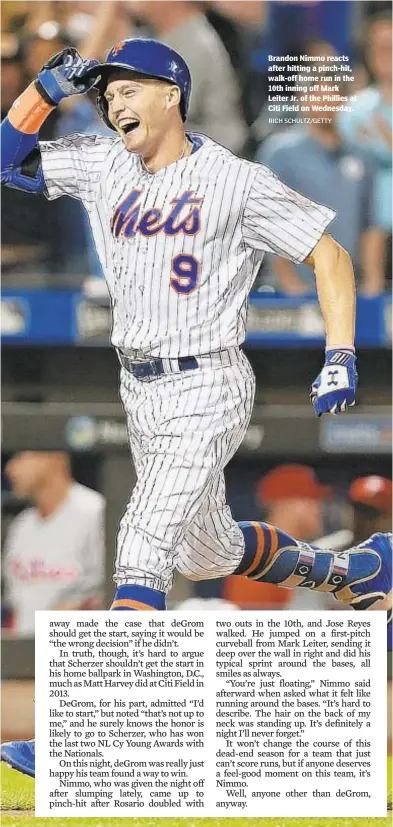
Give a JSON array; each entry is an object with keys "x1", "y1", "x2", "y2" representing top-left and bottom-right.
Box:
[{"x1": 2, "y1": 39, "x2": 391, "y2": 774}]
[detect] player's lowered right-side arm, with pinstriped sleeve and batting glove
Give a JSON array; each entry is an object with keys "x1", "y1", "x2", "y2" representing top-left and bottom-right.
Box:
[{"x1": 242, "y1": 165, "x2": 357, "y2": 416}]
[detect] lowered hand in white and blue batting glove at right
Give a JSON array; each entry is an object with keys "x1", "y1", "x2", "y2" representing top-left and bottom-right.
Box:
[{"x1": 310, "y1": 349, "x2": 358, "y2": 416}]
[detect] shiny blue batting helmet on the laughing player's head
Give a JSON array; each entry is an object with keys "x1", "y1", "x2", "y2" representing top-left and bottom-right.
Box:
[{"x1": 85, "y1": 38, "x2": 191, "y2": 129}]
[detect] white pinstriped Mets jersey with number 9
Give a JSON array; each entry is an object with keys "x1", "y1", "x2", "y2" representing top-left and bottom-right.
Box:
[{"x1": 40, "y1": 134, "x2": 335, "y2": 357}]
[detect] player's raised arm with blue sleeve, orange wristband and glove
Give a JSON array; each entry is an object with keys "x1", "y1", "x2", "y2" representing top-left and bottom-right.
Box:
[{"x1": 1, "y1": 48, "x2": 101, "y2": 193}]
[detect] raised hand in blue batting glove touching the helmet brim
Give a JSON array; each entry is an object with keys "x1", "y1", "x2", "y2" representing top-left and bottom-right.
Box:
[{"x1": 37, "y1": 46, "x2": 99, "y2": 106}]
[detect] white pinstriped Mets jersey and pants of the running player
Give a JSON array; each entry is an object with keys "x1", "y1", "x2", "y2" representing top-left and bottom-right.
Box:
[{"x1": 40, "y1": 135, "x2": 335, "y2": 592}]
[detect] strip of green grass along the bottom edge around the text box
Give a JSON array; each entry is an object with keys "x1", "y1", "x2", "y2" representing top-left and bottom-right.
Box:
[{"x1": 1, "y1": 758, "x2": 392, "y2": 827}]
